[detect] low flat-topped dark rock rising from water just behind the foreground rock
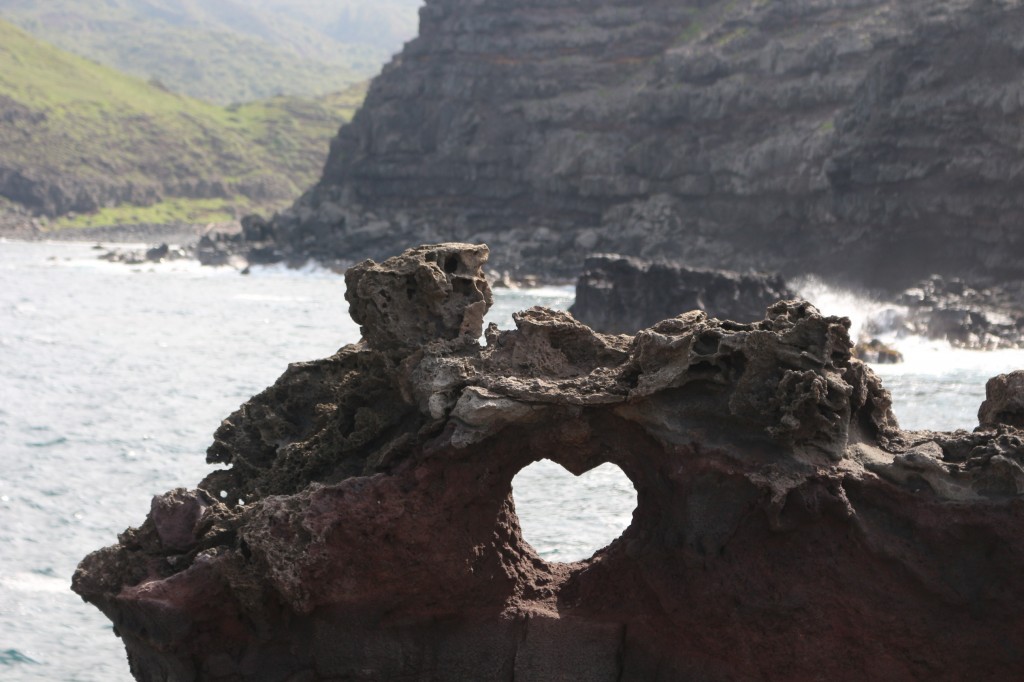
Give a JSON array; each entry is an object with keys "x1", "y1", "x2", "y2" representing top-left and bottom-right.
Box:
[{"x1": 569, "y1": 254, "x2": 796, "y2": 334}]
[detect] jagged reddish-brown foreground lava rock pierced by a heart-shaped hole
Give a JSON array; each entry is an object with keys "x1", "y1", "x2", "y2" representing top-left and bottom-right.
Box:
[{"x1": 74, "y1": 244, "x2": 1024, "y2": 682}]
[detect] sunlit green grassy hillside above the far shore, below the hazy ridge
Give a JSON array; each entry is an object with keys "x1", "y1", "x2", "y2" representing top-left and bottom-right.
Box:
[{"x1": 0, "y1": 22, "x2": 364, "y2": 223}]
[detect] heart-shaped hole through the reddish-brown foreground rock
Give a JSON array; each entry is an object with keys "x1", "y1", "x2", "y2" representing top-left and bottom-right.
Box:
[{"x1": 512, "y1": 460, "x2": 637, "y2": 562}]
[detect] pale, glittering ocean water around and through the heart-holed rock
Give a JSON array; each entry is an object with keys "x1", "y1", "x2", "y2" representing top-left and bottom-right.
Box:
[{"x1": 0, "y1": 241, "x2": 1024, "y2": 682}]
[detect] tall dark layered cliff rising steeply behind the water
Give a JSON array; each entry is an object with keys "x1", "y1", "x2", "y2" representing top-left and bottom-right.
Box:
[{"x1": 260, "y1": 0, "x2": 1024, "y2": 289}]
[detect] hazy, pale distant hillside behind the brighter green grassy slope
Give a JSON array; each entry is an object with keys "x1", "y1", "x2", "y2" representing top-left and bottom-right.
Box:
[{"x1": 0, "y1": 0, "x2": 420, "y2": 104}]
